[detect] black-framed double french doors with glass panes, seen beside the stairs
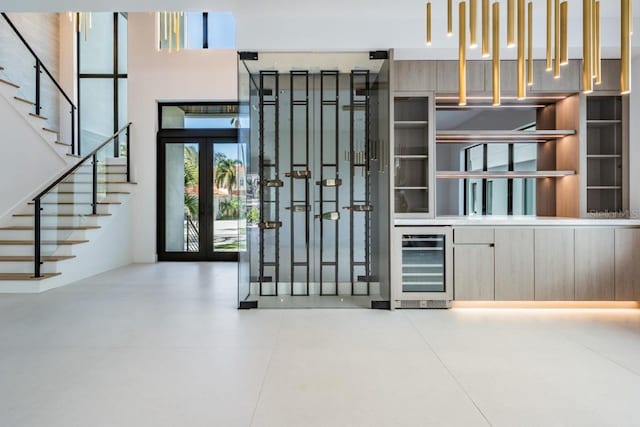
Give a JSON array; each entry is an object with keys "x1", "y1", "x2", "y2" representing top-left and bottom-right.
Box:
[{"x1": 158, "y1": 130, "x2": 246, "y2": 261}]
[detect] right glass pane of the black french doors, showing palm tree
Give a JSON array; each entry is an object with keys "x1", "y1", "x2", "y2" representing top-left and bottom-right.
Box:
[{"x1": 213, "y1": 143, "x2": 247, "y2": 252}]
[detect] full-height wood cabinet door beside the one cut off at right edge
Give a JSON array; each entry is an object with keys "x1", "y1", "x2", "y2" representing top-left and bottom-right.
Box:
[{"x1": 575, "y1": 228, "x2": 615, "y2": 301}]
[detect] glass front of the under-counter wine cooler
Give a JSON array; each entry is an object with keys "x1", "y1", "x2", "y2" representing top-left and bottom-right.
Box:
[{"x1": 402, "y1": 235, "x2": 445, "y2": 292}]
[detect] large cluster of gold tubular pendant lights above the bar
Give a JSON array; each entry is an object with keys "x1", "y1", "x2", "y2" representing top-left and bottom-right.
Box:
[{"x1": 426, "y1": 0, "x2": 633, "y2": 105}]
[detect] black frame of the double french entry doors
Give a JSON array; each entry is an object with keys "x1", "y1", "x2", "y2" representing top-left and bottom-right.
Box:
[{"x1": 156, "y1": 127, "x2": 238, "y2": 261}]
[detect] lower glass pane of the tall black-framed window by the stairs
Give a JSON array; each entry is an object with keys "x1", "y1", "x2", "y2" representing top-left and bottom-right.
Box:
[{"x1": 80, "y1": 79, "x2": 114, "y2": 153}]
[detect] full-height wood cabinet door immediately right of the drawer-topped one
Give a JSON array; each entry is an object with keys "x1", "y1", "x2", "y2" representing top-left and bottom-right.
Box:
[{"x1": 495, "y1": 228, "x2": 534, "y2": 301}]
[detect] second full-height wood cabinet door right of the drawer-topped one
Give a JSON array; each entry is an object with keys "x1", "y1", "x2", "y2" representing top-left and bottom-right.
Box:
[{"x1": 534, "y1": 228, "x2": 575, "y2": 301}]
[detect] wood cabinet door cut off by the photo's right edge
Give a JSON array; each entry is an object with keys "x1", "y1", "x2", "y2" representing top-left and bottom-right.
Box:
[{"x1": 615, "y1": 228, "x2": 640, "y2": 301}]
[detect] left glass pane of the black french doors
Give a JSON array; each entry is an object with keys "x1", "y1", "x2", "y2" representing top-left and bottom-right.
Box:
[{"x1": 165, "y1": 143, "x2": 200, "y2": 252}]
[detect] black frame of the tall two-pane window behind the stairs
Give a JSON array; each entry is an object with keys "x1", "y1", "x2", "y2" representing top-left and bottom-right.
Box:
[{"x1": 76, "y1": 12, "x2": 128, "y2": 157}]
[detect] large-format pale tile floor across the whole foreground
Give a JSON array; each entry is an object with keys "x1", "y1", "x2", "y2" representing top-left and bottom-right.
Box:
[{"x1": 0, "y1": 263, "x2": 640, "y2": 427}]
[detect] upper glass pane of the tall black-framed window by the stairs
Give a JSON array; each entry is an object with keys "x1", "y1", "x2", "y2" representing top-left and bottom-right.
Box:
[{"x1": 80, "y1": 12, "x2": 115, "y2": 74}]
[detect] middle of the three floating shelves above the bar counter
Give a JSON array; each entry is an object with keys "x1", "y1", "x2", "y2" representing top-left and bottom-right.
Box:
[{"x1": 436, "y1": 130, "x2": 576, "y2": 144}]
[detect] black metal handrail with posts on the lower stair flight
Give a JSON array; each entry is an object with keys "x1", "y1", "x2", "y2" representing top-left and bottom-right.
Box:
[{"x1": 33, "y1": 122, "x2": 131, "y2": 277}]
